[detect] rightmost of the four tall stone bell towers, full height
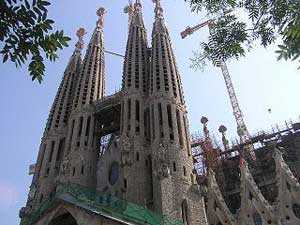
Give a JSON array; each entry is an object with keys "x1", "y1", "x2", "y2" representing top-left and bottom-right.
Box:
[{"x1": 149, "y1": 0, "x2": 206, "y2": 225}]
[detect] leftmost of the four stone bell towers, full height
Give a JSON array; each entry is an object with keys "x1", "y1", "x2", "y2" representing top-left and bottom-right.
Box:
[{"x1": 27, "y1": 28, "x2": 85, "y2": 213}]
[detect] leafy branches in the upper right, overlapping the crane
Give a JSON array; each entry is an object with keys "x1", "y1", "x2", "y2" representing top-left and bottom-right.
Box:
[{"x1": 185, "y1": 0, "x2": 300, "y2": 68}]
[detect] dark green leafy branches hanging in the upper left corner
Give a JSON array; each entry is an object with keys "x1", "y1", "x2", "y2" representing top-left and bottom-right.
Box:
[{"x1": 0, "y1": 0, "x2": 70, "y2": 83}]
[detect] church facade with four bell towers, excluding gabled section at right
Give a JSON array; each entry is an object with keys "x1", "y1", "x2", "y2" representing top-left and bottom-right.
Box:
[{"x1": 20, "y1": 1, "x2": 207, "y2": 225}]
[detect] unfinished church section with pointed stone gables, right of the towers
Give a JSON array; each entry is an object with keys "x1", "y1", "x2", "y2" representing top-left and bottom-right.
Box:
[{"x1": 192, "y1": 118, "x2": 300, "y2": 225}]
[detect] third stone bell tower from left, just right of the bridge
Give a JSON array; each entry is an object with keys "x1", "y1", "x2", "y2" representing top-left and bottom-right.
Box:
[{"x1": 121, "y1": 1, "x2": 152, "y2": 205}]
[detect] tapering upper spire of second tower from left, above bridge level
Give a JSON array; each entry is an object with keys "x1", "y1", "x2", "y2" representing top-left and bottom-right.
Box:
[{"x1": 73, "y1": 7, "x2": 106, "y2": 109}]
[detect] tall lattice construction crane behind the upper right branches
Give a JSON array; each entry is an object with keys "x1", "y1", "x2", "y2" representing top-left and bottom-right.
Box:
[{"x1": 181, "y1": 15, "x2": 255, "y2": 160}]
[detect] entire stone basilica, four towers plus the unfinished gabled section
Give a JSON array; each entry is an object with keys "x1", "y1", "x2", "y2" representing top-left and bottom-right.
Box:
[{"x1": 20, "y1": 0, "x2": 300, "y2": 225}]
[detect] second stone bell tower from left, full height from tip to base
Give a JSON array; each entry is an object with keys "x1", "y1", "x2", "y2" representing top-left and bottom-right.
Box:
[{"x1": 61, "y1": 7, "x2": 105, "y2": 188}]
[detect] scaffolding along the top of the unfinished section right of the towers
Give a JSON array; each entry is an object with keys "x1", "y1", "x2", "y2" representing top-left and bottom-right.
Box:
[{"x1": 191, "y1": 121, "x2": 300, "y2": 180}]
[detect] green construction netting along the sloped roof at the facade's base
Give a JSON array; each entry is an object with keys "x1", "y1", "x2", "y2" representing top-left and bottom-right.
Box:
[{"x1": 22, "y1": 184, "x2": 183, "y2": 225}]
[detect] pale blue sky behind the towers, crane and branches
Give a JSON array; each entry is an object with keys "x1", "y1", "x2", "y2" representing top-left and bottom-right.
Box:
[{"x1": 0, "y1": 0, "x2": 300, "y2": 225}]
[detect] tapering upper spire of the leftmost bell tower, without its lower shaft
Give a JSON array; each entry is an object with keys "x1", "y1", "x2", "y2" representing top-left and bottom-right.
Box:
[{"x1": 46, "y1": 28, "x2": 85, "y2": 132}]
